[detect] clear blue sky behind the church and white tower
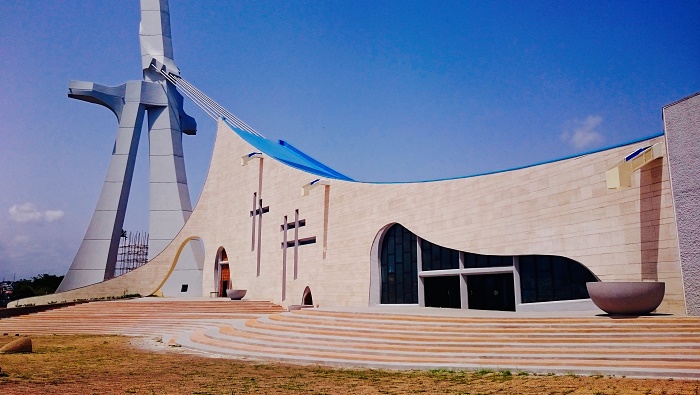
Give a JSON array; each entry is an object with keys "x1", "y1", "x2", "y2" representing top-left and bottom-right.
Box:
[{"x1": 0, "y1": 0, "x2": 700, "y2": 280}]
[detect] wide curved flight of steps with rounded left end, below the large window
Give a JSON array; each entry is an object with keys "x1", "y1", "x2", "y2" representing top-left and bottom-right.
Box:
[{"x1": 176, "y1": 310, "x2": 700, "y2": 378}]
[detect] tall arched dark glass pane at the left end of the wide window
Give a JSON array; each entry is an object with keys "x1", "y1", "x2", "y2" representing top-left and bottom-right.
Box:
[{"x1": 379, "y1": 224, "x2": 418, "y2": 304}]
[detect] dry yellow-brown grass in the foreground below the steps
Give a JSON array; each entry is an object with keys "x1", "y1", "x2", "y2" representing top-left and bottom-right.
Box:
[{"x1": 0, "y1": 335, "x2": 700, "y2": 395}]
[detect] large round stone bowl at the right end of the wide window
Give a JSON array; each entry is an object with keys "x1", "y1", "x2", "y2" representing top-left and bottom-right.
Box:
[{"x1": 586, "y1": 282, "x2": 666, "y2": 315}]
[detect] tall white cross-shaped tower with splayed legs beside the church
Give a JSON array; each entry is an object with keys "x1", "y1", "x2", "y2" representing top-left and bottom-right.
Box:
[{"x1": 57, "y1": 0, "x2": 201, "y2": 292}]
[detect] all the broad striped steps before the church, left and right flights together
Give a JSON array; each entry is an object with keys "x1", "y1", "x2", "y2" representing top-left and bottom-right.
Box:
[{"x1": 0, "y1": 298, "x2": 700, "y2": 379}]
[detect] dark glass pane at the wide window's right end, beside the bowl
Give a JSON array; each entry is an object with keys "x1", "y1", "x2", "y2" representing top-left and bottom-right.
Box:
[{"x1": 519, "y1": 255, "x2": 598, "y2": 303}]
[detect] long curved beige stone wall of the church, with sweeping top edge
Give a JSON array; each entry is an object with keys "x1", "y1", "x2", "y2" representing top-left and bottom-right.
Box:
[{"x1": 13, "y1": 123, "x2": 685, "y2": 313}]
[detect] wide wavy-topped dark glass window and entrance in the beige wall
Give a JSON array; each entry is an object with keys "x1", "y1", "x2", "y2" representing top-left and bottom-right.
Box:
[{"x1": 370, "y1": 224, "x2": 598, "y2": 311}]
